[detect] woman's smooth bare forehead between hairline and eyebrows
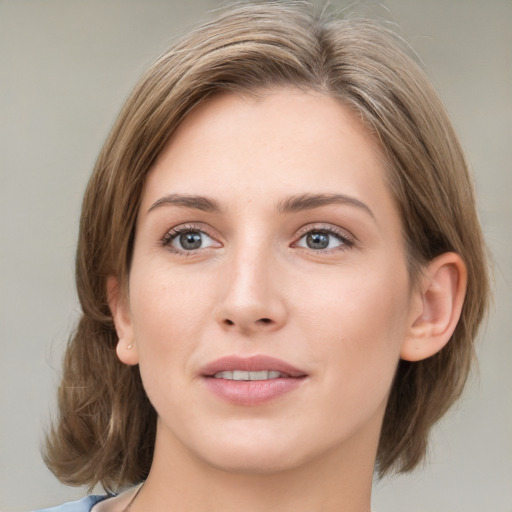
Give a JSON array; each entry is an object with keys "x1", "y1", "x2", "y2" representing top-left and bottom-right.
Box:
[{"x1": 143, "y1": 89, "x2": 391, "y2": 217}]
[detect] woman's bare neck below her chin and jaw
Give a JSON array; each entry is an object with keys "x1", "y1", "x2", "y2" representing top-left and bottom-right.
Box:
[{"x1": 134, "y1": 420, "x2": 377, "y2": 512}]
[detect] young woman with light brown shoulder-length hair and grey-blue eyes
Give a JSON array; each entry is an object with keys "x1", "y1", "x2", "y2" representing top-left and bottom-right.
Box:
[{"x1": 36, "y1": 2, "x2": 488, "y2": 512}]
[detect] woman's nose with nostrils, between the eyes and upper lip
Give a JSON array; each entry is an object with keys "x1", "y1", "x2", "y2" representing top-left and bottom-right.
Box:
[{"x1": 216, "y1": 242, "x2": 287, "y2": 335}]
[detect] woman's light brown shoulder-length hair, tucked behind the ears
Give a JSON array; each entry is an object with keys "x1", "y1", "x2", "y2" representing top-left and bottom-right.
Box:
[{"x1": 45, "y1": 1, "x2": 489, "y2": 496}]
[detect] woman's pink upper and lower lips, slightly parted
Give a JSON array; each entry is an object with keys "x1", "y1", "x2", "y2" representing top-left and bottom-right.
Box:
[{"x1": 201, "y1": 355, "x2": 307, "y2": 406}]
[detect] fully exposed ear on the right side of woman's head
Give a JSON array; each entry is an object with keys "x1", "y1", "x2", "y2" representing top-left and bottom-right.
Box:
[{"x1": 400, "y1": 252, "x2": 467, "y2": 361}]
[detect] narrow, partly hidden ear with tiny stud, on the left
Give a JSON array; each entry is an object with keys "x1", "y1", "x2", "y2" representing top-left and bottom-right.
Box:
[{"x1": 107, "y1": 276, "x2": 139, "y2": 365}]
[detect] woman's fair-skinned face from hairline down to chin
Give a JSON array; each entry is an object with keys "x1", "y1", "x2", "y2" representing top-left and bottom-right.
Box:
[{"x1": 115, "y1": 89, "x2": 419, "y2": 472}]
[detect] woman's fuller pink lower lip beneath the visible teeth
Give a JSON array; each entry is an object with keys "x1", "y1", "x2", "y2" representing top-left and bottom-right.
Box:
[{"x1": 205, "y1": 377, "x2": 305, "y2": 405}]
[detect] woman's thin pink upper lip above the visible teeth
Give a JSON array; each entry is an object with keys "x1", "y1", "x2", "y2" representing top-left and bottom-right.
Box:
[{"x1": 201, "y1": 355, "x2": 307, "y2": 377}]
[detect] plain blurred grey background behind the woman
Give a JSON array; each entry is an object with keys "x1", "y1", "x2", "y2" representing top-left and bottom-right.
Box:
[{"x1": 0, "y1": 0, "x2": 512, "y2": 512}]
